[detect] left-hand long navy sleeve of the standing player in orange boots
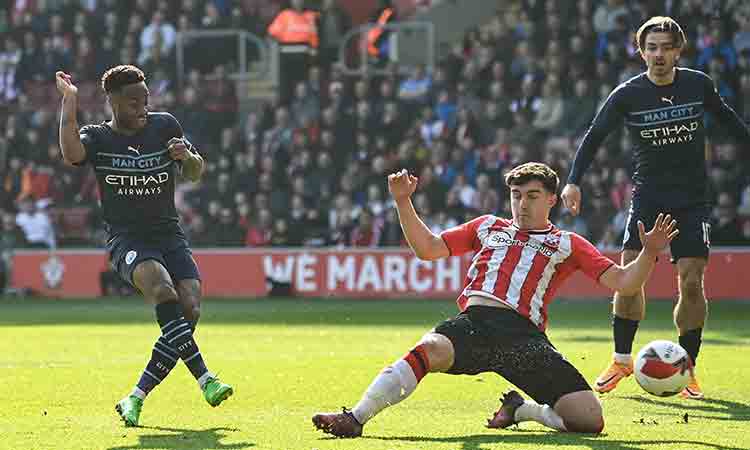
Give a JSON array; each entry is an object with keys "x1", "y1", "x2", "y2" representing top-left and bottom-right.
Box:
[{"x1": 568, "y1": 86, "x2": 624, "y2": 184}]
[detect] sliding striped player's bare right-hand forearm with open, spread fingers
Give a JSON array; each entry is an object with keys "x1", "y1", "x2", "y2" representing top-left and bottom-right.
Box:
[{"x1": 599, "y1": 214, "x2": 679, "y2": 296}]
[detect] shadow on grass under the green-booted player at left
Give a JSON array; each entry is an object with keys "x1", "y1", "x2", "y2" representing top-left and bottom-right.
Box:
[{"x1": 108, "y1": 427, "x2": 255, "y2": 450}]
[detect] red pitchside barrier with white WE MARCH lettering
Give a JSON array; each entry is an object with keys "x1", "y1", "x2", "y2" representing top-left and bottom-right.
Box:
[{"x1": 12, "y1": 248, "x2": 750, "y2": 300}]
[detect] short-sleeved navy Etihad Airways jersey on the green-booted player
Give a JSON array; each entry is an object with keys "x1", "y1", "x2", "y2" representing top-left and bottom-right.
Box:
[{"x1": 80, "y1": 113, "x2": 188, "y2": 237}]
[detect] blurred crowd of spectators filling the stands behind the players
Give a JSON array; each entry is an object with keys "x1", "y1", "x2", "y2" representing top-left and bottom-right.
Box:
[{"x1": 0, "y1": 0, "x2": 750, "y2": 251}]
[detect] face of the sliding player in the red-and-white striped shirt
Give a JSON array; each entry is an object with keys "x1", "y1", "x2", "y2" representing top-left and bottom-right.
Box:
[{"x1": 510, "y1": 180, "x2": 557, "y2": 230}]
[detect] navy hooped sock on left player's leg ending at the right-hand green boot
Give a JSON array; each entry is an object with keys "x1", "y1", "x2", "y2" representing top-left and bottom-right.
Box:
[{"x1": 156, "y1": 302, "x2": 208, "y2": 380}]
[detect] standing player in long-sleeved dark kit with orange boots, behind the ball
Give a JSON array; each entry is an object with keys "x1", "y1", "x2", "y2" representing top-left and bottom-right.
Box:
[{"x1": 562, "y1": 17, "x2": 750, "y2": 399}]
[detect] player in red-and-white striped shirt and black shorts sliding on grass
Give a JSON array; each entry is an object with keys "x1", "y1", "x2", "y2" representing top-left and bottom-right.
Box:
[{"x1": 312, "y1": 163, "x2": 678, "y2": 437}]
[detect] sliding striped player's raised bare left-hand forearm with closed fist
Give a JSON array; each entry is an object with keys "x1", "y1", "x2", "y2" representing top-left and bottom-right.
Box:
[{"x1": 388, "y1": 169, "x2": 450, "y2": 261}]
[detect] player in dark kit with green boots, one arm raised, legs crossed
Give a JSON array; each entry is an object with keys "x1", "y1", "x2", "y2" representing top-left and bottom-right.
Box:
[{"x1": 55, "y1": 65, "x2": 233, "y2": 426}]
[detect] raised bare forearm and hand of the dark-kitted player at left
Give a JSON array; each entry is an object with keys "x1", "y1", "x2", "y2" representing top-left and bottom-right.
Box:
[{"x1": 55, "y1": 71, "x2": 86, "y2": 164}]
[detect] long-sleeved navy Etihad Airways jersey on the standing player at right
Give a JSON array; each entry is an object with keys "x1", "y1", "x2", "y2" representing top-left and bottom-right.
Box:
[{"x1": 568, "y1": 68, "x2": 750, "y2": 206}]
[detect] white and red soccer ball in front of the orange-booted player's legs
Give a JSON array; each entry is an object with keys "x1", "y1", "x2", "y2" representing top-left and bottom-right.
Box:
[{"x1": 635, "y1": 341, "x2": 693, "y2": 397}]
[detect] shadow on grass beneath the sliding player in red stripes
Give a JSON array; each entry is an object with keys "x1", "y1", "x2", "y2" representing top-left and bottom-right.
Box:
[{"x1": 361, "y1": 430, "x2": 742, "y2": 450}]
